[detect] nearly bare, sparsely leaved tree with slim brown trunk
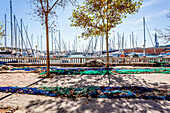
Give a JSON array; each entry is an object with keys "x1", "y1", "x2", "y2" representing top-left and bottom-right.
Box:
[{"x1": 30, "y1": 0, "x2": 76, "y2": 76}]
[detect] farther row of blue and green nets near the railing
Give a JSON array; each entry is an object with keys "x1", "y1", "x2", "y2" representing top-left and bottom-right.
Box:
[{"x1": 11, "y1": 67, "x2": 170, "y2": 75}]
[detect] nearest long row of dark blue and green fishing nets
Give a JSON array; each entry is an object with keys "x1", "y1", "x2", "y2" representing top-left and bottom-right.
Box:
[{"x1": 0, "y1": 86, "x2": 170, "y2": 101}]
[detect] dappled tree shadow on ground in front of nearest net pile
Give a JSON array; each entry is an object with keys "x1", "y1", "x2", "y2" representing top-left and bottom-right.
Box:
[{"x1": 25, "y1": 97, "x2": 170, "y2": 113}]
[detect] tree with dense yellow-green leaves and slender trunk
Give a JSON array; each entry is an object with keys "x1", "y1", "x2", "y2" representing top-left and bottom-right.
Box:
[{"x1": 70, "y1": 0, "x2": 142, "y2": 67}]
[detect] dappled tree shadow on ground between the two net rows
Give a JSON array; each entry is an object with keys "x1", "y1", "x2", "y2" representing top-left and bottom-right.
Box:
[{"x1": 39, "y1": 74, "x2": 170, "y2": 89}]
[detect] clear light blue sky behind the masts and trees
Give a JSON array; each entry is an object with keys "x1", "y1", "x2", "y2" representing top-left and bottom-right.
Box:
[{"x1": 0, "y1": 0, "x2": 170, "y2": 50}]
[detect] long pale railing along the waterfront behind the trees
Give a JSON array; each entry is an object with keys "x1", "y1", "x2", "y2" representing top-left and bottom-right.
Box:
[{"x1": 0, "y1": 57, "x2": 170, "y2": 64}]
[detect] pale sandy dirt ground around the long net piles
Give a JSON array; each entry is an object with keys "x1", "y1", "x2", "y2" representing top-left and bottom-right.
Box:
[{"x1": 0, "y1": 73, "x2": 170, "y2": 113}]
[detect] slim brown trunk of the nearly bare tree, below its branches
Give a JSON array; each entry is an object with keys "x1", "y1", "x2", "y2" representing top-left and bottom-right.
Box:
[{"x1": 45, "y1": 13, "x2": 50, "y2": 76}]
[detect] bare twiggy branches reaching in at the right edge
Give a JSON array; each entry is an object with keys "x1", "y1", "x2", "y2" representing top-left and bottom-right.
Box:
[{"x1": 156, "y1": 10, "x2": 170, "y2": 43}]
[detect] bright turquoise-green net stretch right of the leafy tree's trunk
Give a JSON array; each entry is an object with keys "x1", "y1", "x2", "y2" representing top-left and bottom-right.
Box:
[{"x1": 115, "y1": 68, "x2": 170, "y2": 74}]
